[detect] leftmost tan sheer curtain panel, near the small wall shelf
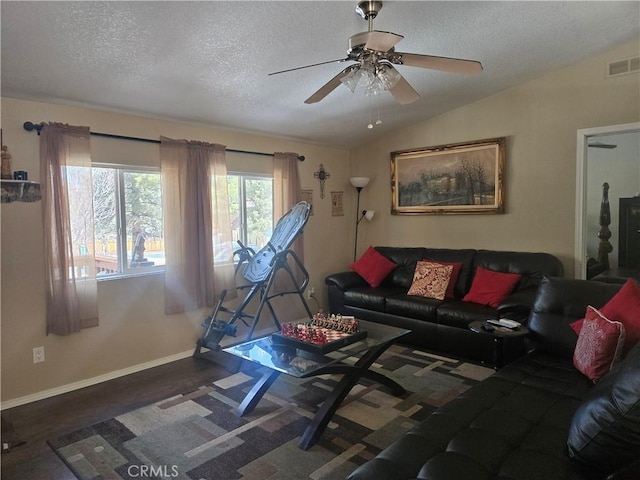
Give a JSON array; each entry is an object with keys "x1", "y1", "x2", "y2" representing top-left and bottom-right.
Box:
[{"x1": 40, "y1": 123, "x2": 98, "y2": 335}]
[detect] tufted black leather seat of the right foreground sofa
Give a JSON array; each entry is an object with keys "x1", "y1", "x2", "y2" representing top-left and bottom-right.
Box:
[{"x1": 348, "y1": 352, "x2": 597, "y2": 480}]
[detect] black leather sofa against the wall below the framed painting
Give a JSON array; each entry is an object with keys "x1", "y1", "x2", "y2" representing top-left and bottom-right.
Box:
[{"x1": 325, "y1": 247, "x2": 563, "y2": 362}]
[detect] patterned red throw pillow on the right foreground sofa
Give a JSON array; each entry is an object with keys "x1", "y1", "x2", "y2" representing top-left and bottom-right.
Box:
[{"x1": 573, "y1": 305, "x2": 625, "y2": 383}]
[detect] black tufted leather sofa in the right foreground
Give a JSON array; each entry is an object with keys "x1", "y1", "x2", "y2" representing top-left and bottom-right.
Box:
[{"x1": 348, "y1": 278, "x2": 640, "y2": 480}]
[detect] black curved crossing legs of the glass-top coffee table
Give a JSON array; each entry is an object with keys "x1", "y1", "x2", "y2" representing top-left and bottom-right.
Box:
[{"x1": 235, "y1": 338, "x2": 406, "y2": 450}]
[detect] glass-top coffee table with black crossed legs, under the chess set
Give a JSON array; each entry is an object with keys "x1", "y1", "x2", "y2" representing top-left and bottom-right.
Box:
[{"x1": 223, "y1": 320, "x2": 411, "y2": 450}]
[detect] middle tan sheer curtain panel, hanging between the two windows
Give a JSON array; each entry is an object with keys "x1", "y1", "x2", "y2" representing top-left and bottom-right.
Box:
[{"x1": 160, "y1": 138, "x2": 235, "y2": 314}]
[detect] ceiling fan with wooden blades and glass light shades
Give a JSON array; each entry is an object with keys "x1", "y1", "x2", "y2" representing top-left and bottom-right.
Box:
[{"x1": 269, "y1": 0, "x2": 482, "y2": 105}]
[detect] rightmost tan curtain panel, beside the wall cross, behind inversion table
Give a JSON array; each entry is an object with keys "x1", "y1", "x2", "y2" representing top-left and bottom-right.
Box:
[{"x1": 273, "y1": 152, "x2": 304, "y2": 262}]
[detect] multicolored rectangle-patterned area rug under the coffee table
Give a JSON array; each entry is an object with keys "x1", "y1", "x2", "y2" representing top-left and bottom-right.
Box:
[{"x1": 49, "y1": 345, "x2": 493, "y2": 480}]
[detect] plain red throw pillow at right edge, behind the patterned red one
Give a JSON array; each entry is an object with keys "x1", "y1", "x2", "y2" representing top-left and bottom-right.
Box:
[{"x1": 569, "y1": 278, "x2": 640, "y2": 356}]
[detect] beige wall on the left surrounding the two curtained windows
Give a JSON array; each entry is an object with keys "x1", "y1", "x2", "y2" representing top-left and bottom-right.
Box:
[{"x1": 1, "y1": 98, "x2": 355, "y2": 408}]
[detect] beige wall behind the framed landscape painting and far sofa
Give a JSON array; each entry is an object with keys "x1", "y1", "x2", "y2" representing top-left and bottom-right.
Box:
[{"x1": 351, "y1": 42, "x2": 640, "y2": 276}]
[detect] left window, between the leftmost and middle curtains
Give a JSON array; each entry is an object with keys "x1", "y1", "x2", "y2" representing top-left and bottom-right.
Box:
[{"x1": 90, "y1": 166, "x2": 165, "y2": 278}]
